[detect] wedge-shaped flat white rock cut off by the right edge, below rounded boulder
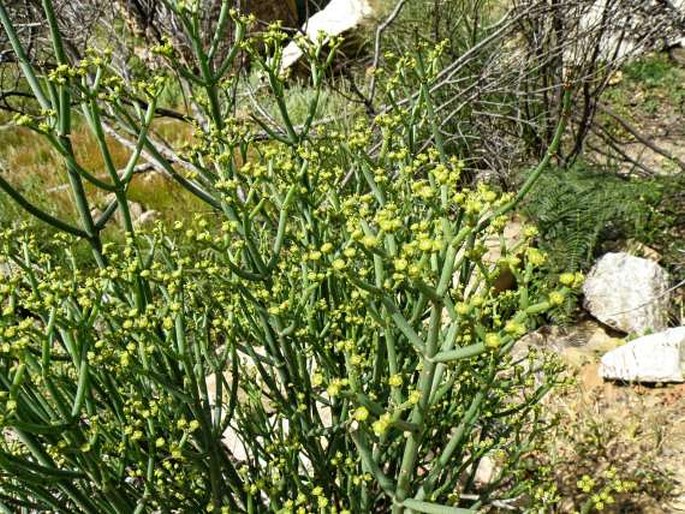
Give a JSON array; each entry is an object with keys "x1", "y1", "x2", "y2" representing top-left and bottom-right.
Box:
[{"x1": 599, "y1": 327, "x2": 685, "y2": 382}]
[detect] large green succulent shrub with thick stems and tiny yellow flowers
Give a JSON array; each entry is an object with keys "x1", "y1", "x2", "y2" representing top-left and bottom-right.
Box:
[{"x1": 0, "y1": 0, "x2": 578, "y2": 514}]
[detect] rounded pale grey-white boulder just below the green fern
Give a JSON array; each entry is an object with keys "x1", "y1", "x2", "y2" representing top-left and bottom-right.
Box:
[{"x1": 583, "y1": 253, "x2": 670, "y2": 334}]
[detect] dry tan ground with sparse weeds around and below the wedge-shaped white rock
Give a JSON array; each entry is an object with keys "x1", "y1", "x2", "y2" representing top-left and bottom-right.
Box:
[{"x1": 526, "y1": 318, "x2": 685, "y2": 514}]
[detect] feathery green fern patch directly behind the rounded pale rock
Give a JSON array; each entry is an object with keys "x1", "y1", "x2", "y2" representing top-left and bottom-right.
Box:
[{"x1": 521, "y1": 162, "x2": 685, "y2": 323}]
